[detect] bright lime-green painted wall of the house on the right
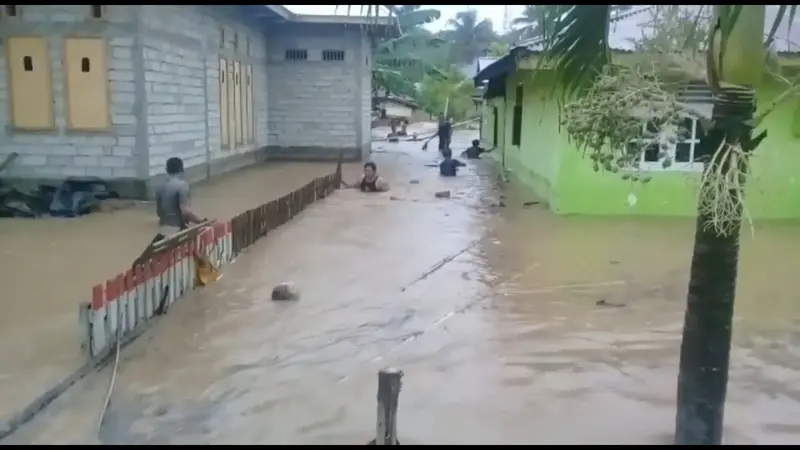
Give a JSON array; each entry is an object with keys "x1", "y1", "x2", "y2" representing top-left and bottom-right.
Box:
[{"x1": 484, "y1": 70, "x2": 800, "y2": 219}]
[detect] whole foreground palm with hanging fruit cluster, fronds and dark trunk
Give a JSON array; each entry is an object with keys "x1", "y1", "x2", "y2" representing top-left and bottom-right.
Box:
[{"x1": 539, "y1": 5, "x2": 798, "y2": 445}]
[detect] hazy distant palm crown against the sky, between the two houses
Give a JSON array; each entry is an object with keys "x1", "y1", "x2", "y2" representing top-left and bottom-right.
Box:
[{"x1": 442, "y1": 9, "x2": 497, "y2": 64}]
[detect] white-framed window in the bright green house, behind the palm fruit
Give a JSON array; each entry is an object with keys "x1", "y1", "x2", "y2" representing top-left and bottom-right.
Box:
[{"x1": 628, "y1": 108, "x2": 704, "y2": 172}]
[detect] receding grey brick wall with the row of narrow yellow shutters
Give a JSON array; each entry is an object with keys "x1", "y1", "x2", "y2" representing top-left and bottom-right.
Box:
[{"x1": 142, "y1": 5, "x2": 268, "y2": 176}]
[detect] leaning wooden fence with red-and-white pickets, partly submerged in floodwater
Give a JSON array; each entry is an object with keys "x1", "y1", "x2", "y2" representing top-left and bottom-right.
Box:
[{"x1": 79, "y1": 162, "x2": 342, "y2": 359}]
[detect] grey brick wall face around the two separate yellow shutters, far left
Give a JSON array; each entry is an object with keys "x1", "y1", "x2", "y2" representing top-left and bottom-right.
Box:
[{"x1": 0, "y1": 5, "x2": 136, "y2": 180}]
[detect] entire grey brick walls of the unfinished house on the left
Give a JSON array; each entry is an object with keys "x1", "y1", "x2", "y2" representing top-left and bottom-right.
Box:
[{"x1": 0, "y1": 5, "x2": 372, "y2": 195}]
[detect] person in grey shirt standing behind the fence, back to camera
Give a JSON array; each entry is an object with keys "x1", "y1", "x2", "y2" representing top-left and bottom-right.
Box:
[{"x1": 153, "y1": 157, "x2": 204, "y2": 242}]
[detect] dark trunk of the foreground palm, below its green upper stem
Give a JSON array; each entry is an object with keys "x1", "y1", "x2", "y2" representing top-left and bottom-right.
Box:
[{"x1": 675, "y1": 89, "x2": 763, "y2": 445}]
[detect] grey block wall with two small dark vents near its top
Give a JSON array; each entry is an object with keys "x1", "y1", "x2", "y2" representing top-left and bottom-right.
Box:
[{"x1": 267, "y1": 24, "x2": 372, "y2": 159}]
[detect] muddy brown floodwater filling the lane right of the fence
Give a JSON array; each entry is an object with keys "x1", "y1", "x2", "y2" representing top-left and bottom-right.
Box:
[{"x1": 4, "y1": 128, "x2": 800, "y2": 444}]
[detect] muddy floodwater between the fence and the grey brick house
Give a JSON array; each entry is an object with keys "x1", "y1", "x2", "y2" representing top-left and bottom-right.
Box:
[{"x1": 0, "y1": 163, "x2": 360, "y2": 426}]
